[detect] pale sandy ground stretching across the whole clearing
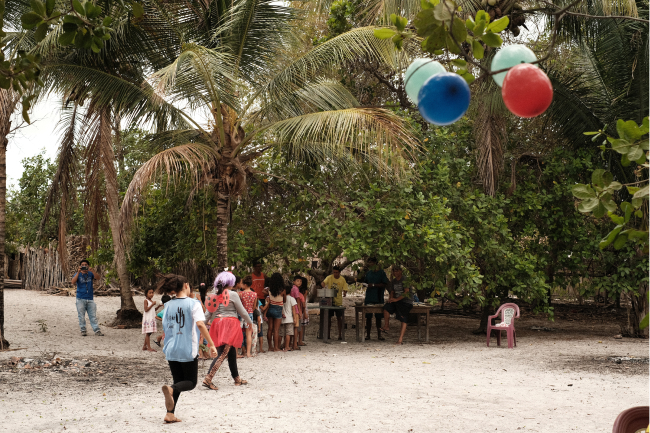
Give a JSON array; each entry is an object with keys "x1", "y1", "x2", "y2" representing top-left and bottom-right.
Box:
[{"x1": 0, "y1": 290, "x2": 648, "y2": 433}]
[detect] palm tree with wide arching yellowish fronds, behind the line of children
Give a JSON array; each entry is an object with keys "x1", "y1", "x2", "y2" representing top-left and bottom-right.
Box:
[{"x1": 114, "y1": 0, "x2": 416, "y2": 268}]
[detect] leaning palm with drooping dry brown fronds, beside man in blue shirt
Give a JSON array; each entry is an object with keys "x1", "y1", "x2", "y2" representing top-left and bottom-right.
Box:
[{"x1": 34, "y1": 2, "x2": 184, "y2": 326}]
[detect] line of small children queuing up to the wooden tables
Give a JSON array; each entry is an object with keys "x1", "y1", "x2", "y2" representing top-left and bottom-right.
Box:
[{"x1": 142, "y1": 272, "x2": 309, "y2": 359}]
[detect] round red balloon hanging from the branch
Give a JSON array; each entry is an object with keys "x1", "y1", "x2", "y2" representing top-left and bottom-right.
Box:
[{"x1": 501, "y1": 63, "x2": 553, "y2": 117}]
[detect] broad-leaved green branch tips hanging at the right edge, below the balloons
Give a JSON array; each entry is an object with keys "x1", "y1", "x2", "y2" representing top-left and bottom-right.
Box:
[{"x1": 572, "y1": 117, "x2": 649, "y2": 251}]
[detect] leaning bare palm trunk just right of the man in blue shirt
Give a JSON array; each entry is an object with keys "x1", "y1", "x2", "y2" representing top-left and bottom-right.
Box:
[{"x1": 100, "y1": 109, "x2": 142, "y2": 327}]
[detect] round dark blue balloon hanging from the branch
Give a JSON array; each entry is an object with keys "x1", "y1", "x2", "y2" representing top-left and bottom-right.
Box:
[{"x1": 418, "y1": 72, "x2": 470, "y2": 126}]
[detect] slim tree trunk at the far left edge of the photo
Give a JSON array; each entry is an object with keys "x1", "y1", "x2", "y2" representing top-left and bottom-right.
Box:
[{"x1": 0, "y1": 90, "x2": 18, "y2": 350}]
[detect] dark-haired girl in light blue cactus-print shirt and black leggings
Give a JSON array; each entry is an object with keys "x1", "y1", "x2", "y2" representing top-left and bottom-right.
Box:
[{"x1": 157, "y1": 274, "x2": 217, "y2": 424}]
